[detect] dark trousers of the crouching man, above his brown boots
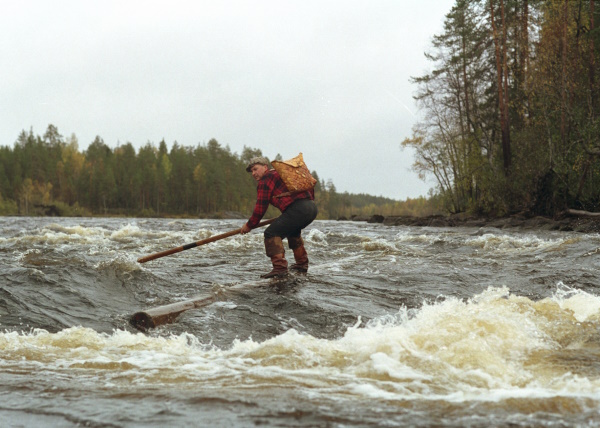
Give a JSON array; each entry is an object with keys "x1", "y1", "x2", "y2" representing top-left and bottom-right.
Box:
[{"x1": 265, "y1": 199, "x2": 318, "y2": 239}]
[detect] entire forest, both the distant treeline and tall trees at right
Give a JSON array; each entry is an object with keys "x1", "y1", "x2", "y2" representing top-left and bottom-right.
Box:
[{"x1": 0, "y1": 0, "x2": 600, "y2": 219}]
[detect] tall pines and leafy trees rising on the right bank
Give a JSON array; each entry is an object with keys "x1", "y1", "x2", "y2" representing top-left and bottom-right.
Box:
[{"x1": 403, "y1": 0, "x2": 600, "y2": 215}]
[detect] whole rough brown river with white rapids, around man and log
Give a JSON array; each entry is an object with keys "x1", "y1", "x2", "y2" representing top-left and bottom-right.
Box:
[{"x1": 0, "y1": 217, "x2": 600, "y2": 428}]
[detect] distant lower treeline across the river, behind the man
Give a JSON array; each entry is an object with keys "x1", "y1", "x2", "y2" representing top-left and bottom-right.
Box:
[{"x1": 0, "y1": 125, "x2": 434, "y2": 219}]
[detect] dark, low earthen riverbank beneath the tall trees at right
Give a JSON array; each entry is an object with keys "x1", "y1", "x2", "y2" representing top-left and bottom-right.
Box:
[{"x1": 340, "y1": 210, "x2": 600, "y2": 233}]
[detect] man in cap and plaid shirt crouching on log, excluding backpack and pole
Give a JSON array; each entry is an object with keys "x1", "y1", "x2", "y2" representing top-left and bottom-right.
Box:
[{"x1": 241, "y1": 156, "x2": 317, "y2": 278}]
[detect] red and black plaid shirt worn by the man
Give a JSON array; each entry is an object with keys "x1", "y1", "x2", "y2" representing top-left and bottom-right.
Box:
[{"x1": 246, "y1": 169, "x2": 315, "y2": 229}]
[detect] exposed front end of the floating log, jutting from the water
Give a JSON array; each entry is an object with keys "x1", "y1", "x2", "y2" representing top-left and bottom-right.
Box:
[{"x1": 129, "y1": 294, "x2": 217, "y2": 331}]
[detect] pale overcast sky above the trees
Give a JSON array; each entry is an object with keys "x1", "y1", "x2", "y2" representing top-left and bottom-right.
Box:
[{"x1": 0, "y1": 0, "x2": 454, "y2": 200}]
